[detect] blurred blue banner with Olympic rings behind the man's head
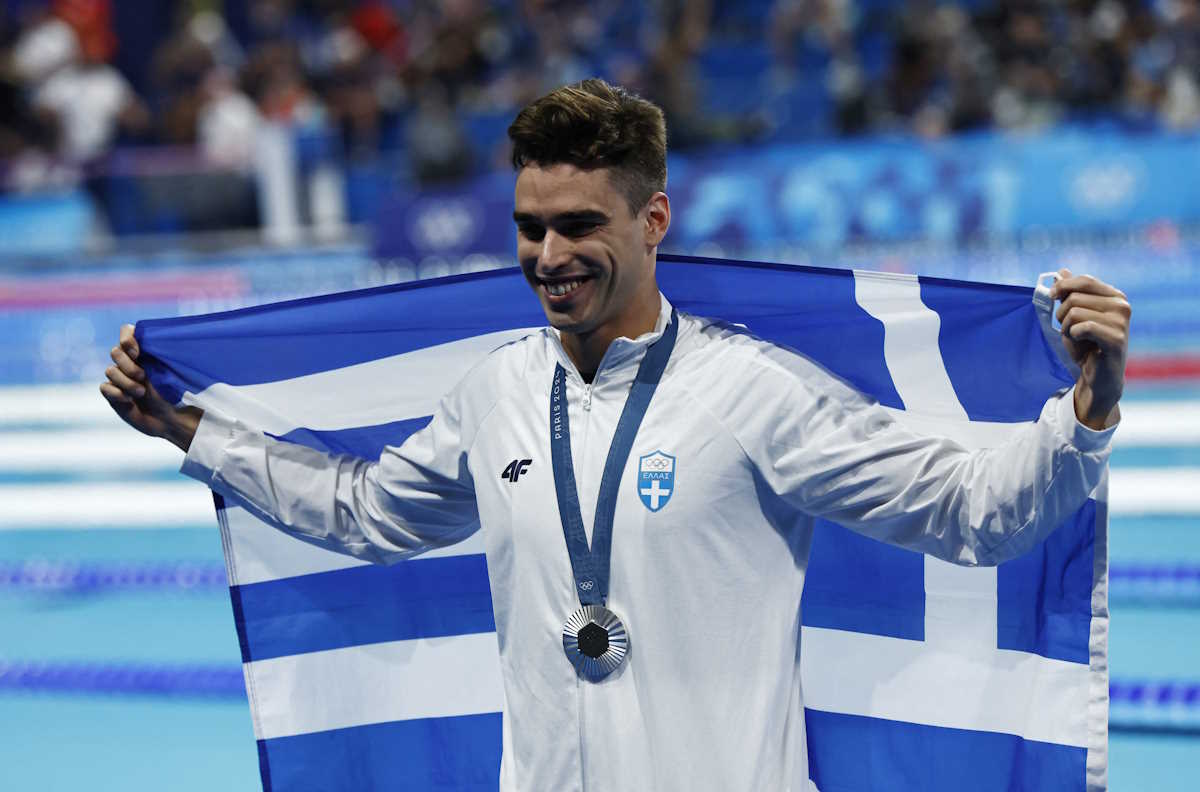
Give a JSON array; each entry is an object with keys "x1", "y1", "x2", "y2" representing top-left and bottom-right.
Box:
[{"x1": 376, "y1": 128, "x2": 1200, "y2": 259}]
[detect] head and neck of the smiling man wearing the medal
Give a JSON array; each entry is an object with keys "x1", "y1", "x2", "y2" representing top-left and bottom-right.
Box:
[{"x1": 509, "y1": 86, "x2": 671, "y2": 380}]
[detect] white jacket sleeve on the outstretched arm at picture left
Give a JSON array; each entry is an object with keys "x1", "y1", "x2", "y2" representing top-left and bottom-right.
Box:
[{"x1": 181, "y1": 386, "x2": 479, "y2": 563}]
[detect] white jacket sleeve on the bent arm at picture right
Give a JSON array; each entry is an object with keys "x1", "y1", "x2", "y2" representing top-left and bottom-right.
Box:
[{"x1": 730, "y1": 355, "x2": 1115, "y2": 565}]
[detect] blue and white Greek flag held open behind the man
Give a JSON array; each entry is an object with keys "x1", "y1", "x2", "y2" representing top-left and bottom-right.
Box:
[{"x1": 137, "y1": 256, "x2": 1108, "y2": 792}]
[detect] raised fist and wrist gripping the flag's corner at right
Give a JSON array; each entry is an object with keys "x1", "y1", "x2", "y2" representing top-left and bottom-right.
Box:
[{"x1": 1050, "y1": 269, "x2": 1129, "y2": 430}]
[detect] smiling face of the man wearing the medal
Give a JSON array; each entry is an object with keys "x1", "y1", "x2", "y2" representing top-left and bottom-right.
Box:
[{"x1": 512, "y1": 164, "x2": 652, "y2": 334}]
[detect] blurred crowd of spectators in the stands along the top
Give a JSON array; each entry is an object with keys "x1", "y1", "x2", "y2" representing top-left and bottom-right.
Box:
[{"x1": 0, "y1": 0, "x2": 1200, "y2": 196}]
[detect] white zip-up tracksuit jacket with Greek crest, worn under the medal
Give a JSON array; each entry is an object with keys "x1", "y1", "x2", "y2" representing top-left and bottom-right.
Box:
[{"x1": 184, "y1": 299, "x2": 1112, "y2": 792}]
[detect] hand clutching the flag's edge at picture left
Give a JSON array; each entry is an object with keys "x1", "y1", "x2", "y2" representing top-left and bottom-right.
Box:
[{"x1": 100, "y1": 324, "x2": 204, "y2": 451}]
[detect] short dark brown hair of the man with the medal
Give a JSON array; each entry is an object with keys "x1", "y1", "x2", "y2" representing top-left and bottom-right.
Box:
[{"x1": 509, "y1": 79, "x2": 667, "y2": 214}]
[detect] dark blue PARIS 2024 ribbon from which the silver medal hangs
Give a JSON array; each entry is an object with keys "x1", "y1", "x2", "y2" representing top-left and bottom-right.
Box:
[{"x1": 550, "y1": 311, "x2": 679, "y2": 605}]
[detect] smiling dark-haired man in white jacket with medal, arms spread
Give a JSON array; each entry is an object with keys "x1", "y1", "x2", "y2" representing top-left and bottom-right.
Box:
[{"x1": 101, "y1": 80, "x2": 1129, "y2": 792}]
